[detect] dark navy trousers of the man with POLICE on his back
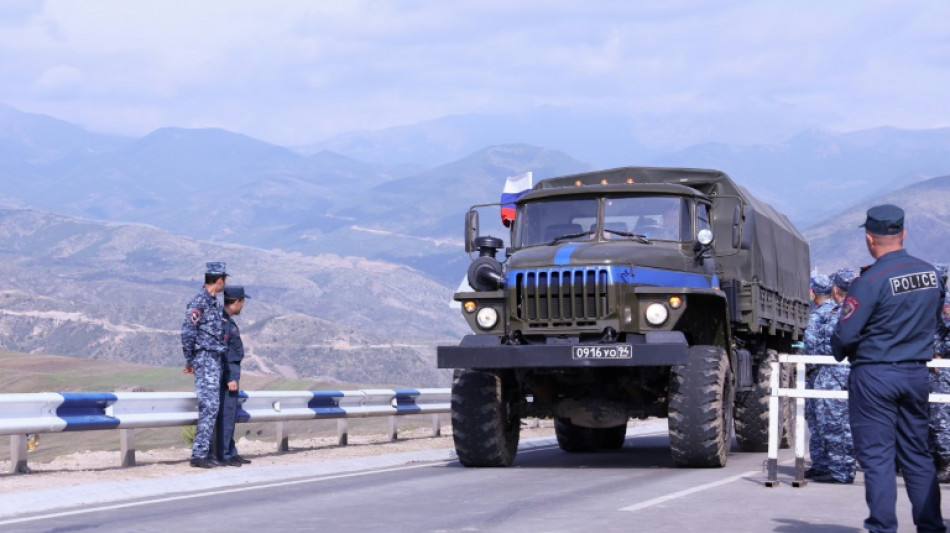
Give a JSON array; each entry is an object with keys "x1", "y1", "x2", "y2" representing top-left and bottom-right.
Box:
[{"x1": 848, "y1": 362, "x2": 946, "y2": 533}]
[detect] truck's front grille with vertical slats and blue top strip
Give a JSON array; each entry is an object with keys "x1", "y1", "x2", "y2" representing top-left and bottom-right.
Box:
[{"x1": 514, "y1": 268, "x2": 610, "y2": 327}]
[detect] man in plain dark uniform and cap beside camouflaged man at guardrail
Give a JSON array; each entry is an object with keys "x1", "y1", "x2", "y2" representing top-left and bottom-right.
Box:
[{"x1": 214, "y1": 285, "x2": 251, "y2": 466}]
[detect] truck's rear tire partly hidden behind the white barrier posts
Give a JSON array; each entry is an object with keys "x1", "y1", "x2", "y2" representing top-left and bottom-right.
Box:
[{"x1": 736, "y1": 350, "x2": 792, "y2": 452}]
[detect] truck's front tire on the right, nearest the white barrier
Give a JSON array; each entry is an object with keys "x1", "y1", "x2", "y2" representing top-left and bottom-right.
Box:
[{"x1": 669, "y1": 346, "x2": 735, "y2": 467}]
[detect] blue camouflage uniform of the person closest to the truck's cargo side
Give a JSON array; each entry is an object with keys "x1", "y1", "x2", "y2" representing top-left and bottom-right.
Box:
[{"x1": 804, "y1": 298, "x2": 836, "y2": 473}]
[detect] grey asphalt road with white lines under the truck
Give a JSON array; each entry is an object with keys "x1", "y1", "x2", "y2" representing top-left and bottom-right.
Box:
[{"x1": 0, "y1": 425, "x2": 950, "y2": 533}]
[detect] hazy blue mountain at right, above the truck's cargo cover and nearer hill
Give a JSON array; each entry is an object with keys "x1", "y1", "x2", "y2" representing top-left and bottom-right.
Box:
[{"x1": 651, "y1": 127, "x2": 950, "y2": 226}]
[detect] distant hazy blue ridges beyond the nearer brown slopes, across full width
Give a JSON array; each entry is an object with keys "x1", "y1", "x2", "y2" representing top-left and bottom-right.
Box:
[{"x1": 0, "y1": 102, "x2": 950, "y2": 287}]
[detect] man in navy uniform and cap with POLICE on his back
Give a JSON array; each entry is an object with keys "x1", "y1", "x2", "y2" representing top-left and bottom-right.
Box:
[{"x1": 831, "y1": 204, "x2": 946, "y2": 532}]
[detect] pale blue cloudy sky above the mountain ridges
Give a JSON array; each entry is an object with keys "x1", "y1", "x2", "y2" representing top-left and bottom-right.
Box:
[{"x1": 0, "y1": 0, "x2": 950, "y2": 145}]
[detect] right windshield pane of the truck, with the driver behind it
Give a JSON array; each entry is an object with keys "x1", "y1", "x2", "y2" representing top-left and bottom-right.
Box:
[{"x1": 604, "y1": 196, "x2": 692, "y2": 241}]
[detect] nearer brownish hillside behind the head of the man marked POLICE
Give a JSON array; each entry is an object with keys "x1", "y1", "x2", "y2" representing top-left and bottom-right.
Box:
[{"x1": 803, "y1": 176, "x2": 950, "y2": 273}]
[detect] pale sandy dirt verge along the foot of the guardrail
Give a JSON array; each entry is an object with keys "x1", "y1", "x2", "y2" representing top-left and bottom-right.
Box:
[{"x1": 0, "y1": 420, "x2": 564, "y2": 494}]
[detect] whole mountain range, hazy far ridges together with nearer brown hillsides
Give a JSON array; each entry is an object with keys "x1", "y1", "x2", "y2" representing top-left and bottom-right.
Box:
[{"x1": 0, "y1": 105, "x2": 950, "y2": 386}]
